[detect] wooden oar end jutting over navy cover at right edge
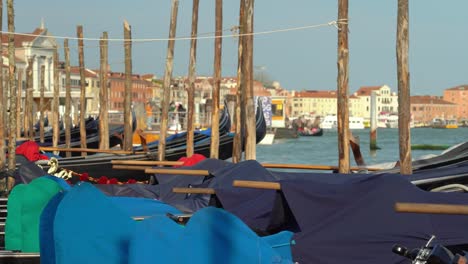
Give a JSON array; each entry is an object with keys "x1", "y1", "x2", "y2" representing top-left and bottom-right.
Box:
[{"x1": 395, "y1": 203, "x2": 468, "y2": 215}]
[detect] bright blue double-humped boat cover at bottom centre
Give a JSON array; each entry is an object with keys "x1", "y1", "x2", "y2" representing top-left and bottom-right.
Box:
[{"x1": 129, "y1": 207, "x2": 293, "y2": 264}]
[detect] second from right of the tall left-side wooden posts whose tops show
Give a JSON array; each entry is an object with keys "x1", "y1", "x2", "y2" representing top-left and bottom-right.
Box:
[{"x1": 99, "y1": 32, "x2": 109, "y2": 149}]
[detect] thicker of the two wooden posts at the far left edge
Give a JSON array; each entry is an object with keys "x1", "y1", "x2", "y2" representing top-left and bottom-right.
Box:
[{"x1": 6, "y1": 0, "x2": 17, "y2": 192}]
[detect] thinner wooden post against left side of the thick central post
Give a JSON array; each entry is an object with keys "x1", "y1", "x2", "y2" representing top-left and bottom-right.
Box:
[{"x1": 232, "y1": 0, "x2": 245, "y2": 163}]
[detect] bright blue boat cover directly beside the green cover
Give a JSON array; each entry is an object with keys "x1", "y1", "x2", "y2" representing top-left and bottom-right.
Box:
[{"x1": 41, "y1": 182, "x2": 181, "y2": 264}]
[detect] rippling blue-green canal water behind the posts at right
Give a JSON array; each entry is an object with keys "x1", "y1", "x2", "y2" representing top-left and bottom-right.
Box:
[{"x1": 257, "y1": 128, "x2": 468, "y2": 165}]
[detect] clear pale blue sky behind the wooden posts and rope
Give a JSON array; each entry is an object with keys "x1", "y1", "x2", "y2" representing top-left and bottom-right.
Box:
[{"x1": 9, "y1": 0, "x2": 468, "y2": 95}]
